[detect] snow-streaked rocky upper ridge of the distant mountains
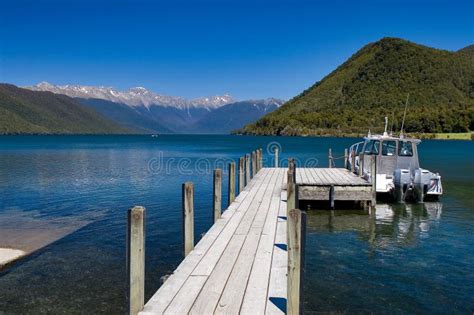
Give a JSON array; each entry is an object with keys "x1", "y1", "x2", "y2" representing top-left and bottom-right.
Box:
[{"x1": 26, "y1": 82, "x2": 235, "y2": 109}]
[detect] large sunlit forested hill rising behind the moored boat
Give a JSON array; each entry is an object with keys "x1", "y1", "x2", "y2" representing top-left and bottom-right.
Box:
[{"x1": 238, "y1": 38, "x2": 474, "y2": 135}]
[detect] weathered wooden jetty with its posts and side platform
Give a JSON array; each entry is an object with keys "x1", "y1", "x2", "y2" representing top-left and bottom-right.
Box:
[{"x1": 127, "y1": 149, "x2": 373, "y2": 315}]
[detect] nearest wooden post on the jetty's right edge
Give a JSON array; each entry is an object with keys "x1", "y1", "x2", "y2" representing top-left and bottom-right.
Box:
[{"x1": 286, "y1": 209, "x2": 306, "y2": 315}]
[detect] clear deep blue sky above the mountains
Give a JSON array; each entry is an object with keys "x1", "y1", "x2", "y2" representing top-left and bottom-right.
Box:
[{"x1": 0, "y1": 0, "x2": 474, "y2": 99}]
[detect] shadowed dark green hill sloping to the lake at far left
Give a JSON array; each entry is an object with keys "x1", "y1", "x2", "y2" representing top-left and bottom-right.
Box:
[{"x1": 0, "y1": 84, "x2": 130, "y2": 134}]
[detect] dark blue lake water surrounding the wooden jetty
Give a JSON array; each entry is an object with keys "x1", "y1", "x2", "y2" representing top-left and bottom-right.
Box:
[{"x1": 0, "y1": 136, "x2": 474, "y2": 314}]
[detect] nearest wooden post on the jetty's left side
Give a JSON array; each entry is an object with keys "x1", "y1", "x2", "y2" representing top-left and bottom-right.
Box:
[{"x1": 127, "y1": 206, "x2": 145, "y2": 315}]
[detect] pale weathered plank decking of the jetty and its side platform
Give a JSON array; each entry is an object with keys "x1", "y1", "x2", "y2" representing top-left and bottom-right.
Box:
[{"x1": 140, "y1": 168, "x2": 370, "y2": 314}]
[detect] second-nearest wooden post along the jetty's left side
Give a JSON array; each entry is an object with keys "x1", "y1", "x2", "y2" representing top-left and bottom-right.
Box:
[{"x1": 183, "y1": 182, "x2": 194, "y2": 257}]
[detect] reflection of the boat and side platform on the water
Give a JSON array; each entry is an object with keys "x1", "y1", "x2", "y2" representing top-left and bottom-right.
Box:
[{"x1": 308, "y1": 202, "x2": 443, "y2": 248}]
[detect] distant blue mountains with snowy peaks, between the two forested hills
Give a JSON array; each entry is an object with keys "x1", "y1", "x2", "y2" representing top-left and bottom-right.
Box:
[{"x1": 26, "y1": 82, "x2": 284, "y2": 133}]
